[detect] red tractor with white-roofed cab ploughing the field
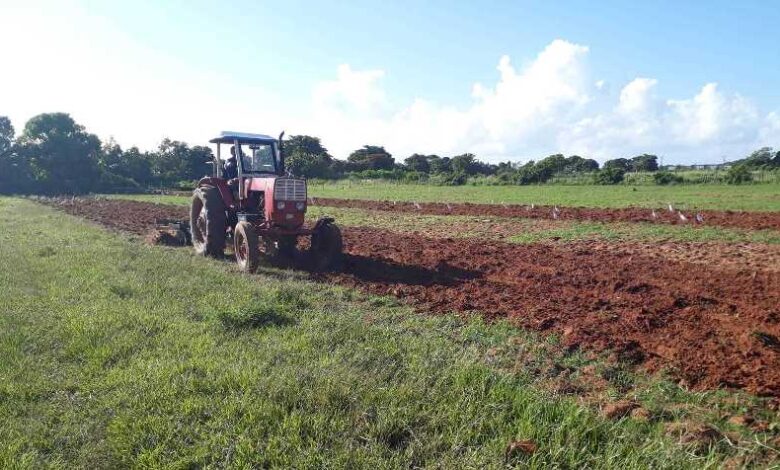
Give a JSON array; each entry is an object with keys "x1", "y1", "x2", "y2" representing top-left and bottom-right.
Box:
[{"x1": 190, "y1": 132, "x2": 342, "y2": 272}]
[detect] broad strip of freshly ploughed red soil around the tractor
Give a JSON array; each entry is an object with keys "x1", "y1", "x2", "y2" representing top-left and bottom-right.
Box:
[{"x1": 45, "y1": 199, "x2": 780, "y2": 397}]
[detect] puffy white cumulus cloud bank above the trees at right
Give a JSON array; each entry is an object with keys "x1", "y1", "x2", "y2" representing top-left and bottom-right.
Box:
[{"x1": 307, "y1": 39, "x2": 780, "y2": 162}]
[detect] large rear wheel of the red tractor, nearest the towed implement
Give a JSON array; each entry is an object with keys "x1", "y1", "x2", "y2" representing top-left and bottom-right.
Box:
[{"x1": 190, "y1": 186, "x2": 227, "y2": 258}]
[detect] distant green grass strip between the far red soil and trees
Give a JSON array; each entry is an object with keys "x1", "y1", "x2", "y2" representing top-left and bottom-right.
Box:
[{"x1": 309, "y1": 181, "x2": 780, "y2": 211}]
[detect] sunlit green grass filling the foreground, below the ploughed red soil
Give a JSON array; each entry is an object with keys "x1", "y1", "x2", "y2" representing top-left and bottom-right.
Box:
[{"x1": 0, "y1": 199, "x2": 774, "y2": 469}]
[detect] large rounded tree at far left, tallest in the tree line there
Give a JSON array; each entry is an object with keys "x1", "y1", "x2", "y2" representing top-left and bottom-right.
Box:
[{"x1": 19, "y1": 113, "x2": 100, "y2": 194}]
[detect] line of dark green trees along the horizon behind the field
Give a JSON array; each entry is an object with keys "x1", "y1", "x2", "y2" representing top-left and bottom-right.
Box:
[{"x1": 0, "y1": 113, "x2": 780, "y2": 194}]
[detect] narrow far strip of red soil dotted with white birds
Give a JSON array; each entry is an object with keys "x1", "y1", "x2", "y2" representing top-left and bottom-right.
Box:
[{"x1": 313, "y1": 198, "x2": 780, "y2": 230}]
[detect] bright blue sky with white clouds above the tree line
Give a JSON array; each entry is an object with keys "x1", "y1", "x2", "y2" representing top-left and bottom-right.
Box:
[{"x1": 0, "y1": 0, "x2": 780, "y2": 163}]
